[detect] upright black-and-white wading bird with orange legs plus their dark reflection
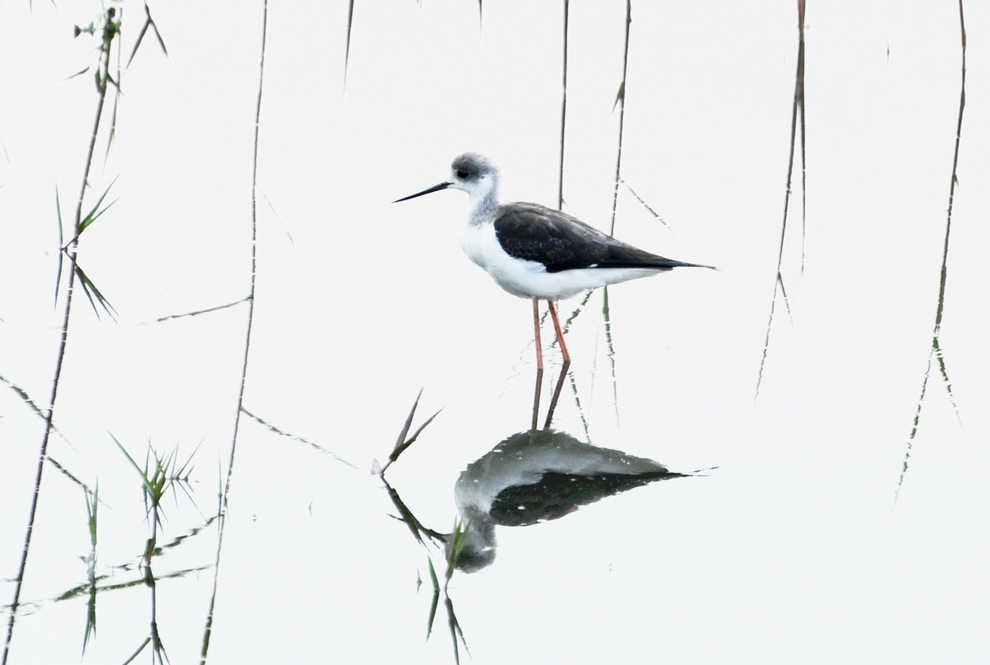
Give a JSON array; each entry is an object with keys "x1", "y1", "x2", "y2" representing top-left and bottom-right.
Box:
[{"x1": 393, "y1": 152, "x2": 713, "y2": 430}]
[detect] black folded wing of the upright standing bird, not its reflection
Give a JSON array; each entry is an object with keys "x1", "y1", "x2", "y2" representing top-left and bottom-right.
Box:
[{"x1": 494, "y1": 203, "x2": 707, "y2": 272}]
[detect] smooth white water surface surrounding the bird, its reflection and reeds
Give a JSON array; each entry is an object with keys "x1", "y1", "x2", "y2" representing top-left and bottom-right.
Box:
[{"x1": 0, "y1": 0, "x2": 990, "y2": 664}]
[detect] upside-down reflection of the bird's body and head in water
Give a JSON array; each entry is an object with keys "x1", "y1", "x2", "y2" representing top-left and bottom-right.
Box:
[{"x1": 446, "y1": 430, "x2": 691, "y2": 573}]
